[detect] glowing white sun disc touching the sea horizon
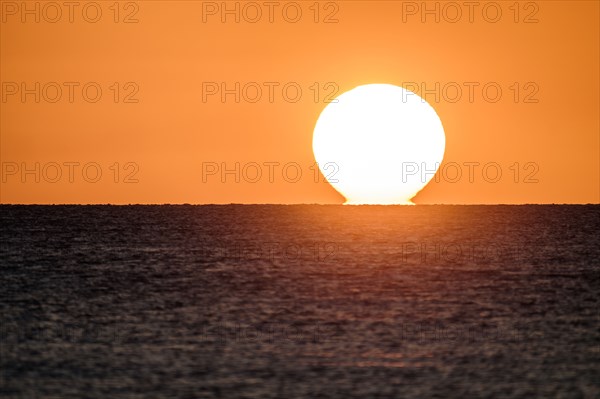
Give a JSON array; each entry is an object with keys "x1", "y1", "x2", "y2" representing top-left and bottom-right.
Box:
[{"x1": 313, "y1": 84, "x2": 446, "y2": 204}]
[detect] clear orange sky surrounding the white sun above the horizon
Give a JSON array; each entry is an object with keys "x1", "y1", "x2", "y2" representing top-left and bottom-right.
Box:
[{"x1": 0, "y1": 1, "x2": 600, "y2": 204}]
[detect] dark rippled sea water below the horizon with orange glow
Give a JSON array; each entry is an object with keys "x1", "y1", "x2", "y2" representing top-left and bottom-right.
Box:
[{"x1": 0, "y1": 205, "x2": 600, "y2": 398}]
